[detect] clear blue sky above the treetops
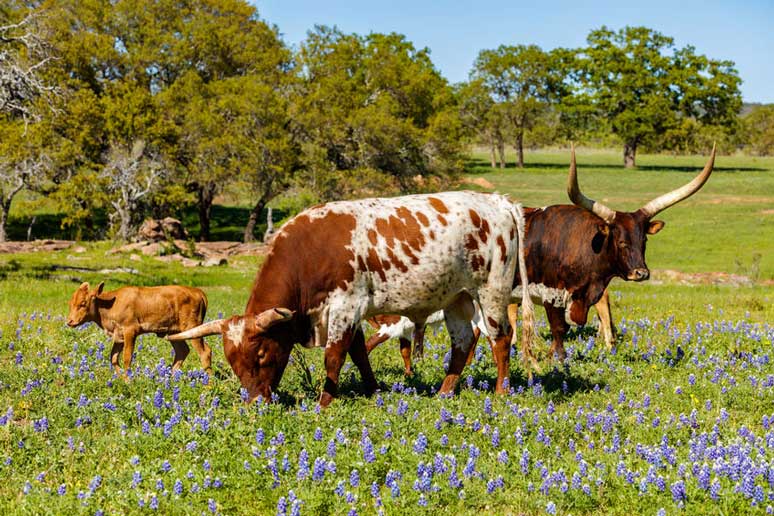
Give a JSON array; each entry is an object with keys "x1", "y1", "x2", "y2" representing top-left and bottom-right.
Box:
[{"x1": 251, "y1": 0, "x2": 774, "y2": 102}]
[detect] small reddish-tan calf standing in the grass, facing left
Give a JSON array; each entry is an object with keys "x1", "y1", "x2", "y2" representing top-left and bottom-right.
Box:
[{"x1": 67, "y1": 283, "x2": 212, "y2": 374}]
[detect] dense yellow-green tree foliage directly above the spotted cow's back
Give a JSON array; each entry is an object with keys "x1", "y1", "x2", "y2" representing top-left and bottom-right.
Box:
[{"x1": 291, "y1": 27, "x2": 462, "y2": 200}]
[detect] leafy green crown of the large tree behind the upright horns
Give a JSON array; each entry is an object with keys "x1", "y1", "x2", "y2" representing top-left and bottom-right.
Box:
[{"x1": 578, "y1": 26, "x2": 741, "y2": 167}]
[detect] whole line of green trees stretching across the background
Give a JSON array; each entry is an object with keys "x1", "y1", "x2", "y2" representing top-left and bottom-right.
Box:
[{"x1": 0, "y1": 0, "x2": 774, "y2": 241}]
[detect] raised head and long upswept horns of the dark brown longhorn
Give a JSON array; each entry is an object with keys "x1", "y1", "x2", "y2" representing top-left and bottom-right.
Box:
[{"x1": 567, "y1": 146, "x2": 715, "y2": 281}]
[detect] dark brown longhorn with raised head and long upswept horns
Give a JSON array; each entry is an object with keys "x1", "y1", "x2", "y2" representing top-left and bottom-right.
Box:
[{"x1": 514, "y1": 146, "x2": 715, "y2": 360}]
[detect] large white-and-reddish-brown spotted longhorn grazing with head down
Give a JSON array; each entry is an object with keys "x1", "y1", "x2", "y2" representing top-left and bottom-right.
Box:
[{"x1": 168, "y1": 192, "x2": 533, "y2": 407}]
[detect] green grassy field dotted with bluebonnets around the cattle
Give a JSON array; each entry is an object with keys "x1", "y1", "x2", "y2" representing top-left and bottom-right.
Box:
[{"x1": 0, "y1": 151, "x2": 774, "y2": 515}]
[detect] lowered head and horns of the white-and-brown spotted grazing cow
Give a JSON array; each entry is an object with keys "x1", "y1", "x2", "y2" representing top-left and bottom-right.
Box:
[{"x1": 167, "y1": 308, "x2": 293, "y2": 402}]
